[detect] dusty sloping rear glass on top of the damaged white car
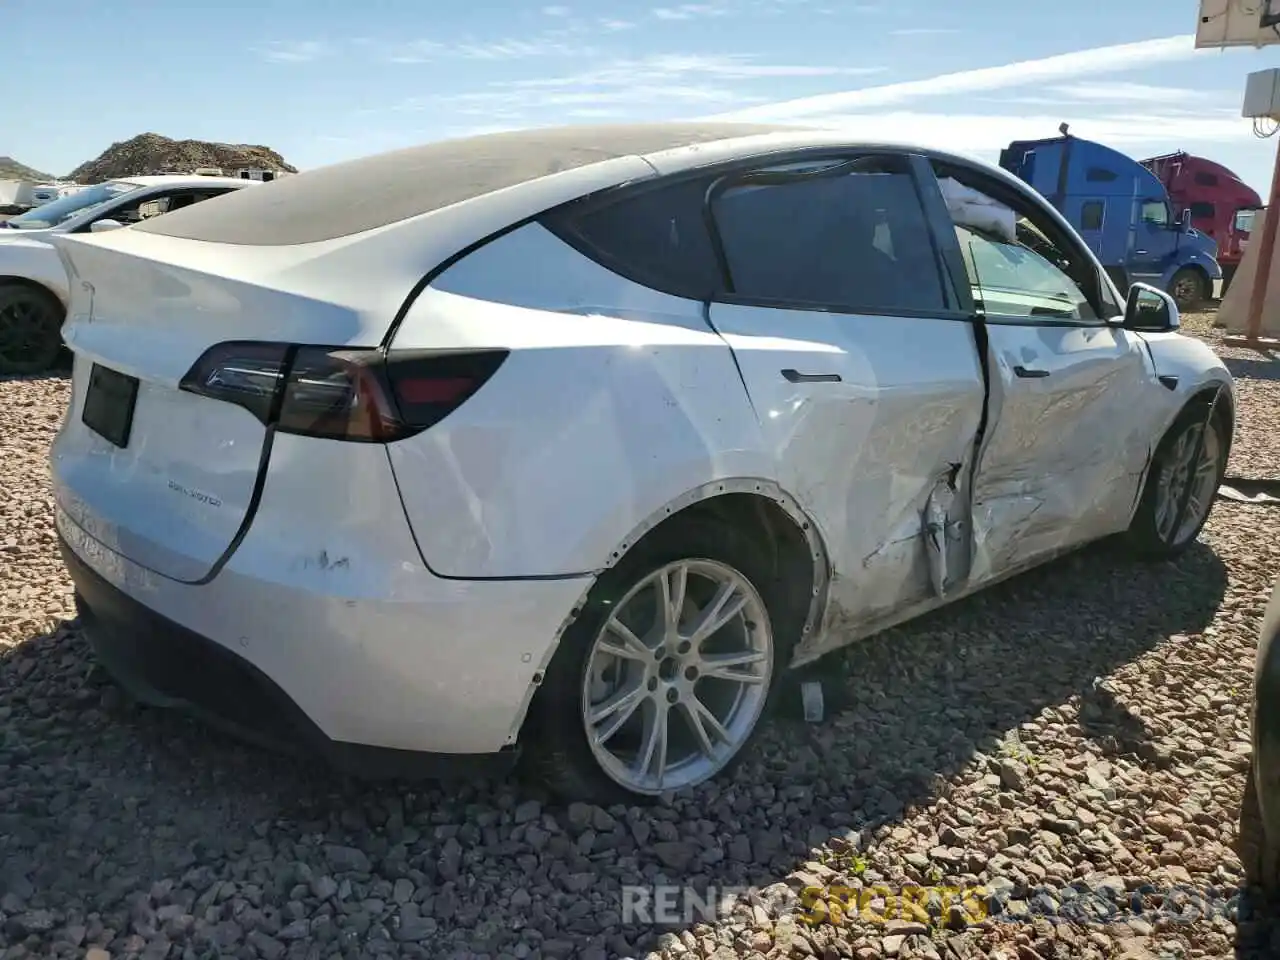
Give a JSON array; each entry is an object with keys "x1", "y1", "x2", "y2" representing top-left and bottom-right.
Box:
[{"x1": 133, "y1": 123, "x2": 783, "y2": 246}]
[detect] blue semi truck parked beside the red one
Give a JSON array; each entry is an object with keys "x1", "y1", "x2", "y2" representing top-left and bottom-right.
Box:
[{"x1": 1000, "y1": 124, "x2": 1222, "y2": 310}]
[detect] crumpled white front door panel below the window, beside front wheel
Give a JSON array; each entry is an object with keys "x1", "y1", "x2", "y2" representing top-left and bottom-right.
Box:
[{"x1": 972, "y1": 323, "x2": 1169, "y2": 585}]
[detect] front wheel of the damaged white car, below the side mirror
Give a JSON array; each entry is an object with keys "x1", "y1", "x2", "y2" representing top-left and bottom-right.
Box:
[{"x1": 1128, "y1": 403, "x2": 1226, "y2": 559}]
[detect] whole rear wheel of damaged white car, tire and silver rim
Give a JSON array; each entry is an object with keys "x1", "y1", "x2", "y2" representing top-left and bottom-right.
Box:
[{"x1": 526, "y1": 521, "x2": 790, "y2": 804}]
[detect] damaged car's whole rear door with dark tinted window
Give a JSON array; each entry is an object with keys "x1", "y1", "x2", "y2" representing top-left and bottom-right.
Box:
[{"x1": 709, "y1": 154, "x2": 984, "y2": 645}]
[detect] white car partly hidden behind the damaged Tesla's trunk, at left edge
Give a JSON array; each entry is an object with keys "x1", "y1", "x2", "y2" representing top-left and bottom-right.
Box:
[{"x1": 0, "y1": 177, "x2": 257, "y2": 375}]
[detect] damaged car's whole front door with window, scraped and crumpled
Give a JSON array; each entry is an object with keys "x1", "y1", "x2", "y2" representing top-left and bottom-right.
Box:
[{"x1": 936, "y1": 170, "x2": 1167, "y2": 585}]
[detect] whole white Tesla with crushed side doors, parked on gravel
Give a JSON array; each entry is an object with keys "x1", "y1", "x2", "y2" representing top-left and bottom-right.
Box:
[{"x1": 52, "y1": 124, "x2": 1235, "y2": 801}]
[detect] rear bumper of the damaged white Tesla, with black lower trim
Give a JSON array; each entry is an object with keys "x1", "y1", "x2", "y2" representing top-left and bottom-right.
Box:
[{"x1": 56, "y1": 509, "x2": 586, "y2": 777}]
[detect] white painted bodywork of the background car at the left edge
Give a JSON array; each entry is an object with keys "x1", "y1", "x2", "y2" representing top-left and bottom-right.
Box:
[{"x1": 0, "y1": 175, "x2": 256, "y2": 307}]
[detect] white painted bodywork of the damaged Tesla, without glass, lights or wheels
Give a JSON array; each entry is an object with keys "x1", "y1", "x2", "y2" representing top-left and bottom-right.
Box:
[{"x1": 52, "y1": 133, "x2": 1233, "y2": 753}]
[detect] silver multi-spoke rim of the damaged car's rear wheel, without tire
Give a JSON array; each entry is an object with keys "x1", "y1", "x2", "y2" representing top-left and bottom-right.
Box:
[{"x1": 581, "y1": 559, "x2": 774, "y2": 795}]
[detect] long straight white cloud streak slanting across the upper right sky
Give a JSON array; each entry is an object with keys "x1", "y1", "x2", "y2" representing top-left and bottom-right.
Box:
[{"x1": 707, "y1": 35, "x2": 1212, "y2": 122}]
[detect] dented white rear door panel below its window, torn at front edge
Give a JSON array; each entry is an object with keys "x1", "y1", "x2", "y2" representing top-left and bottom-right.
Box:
[{"x1": 709, "y1": 303, "x2": 984, "y2": 657}]
